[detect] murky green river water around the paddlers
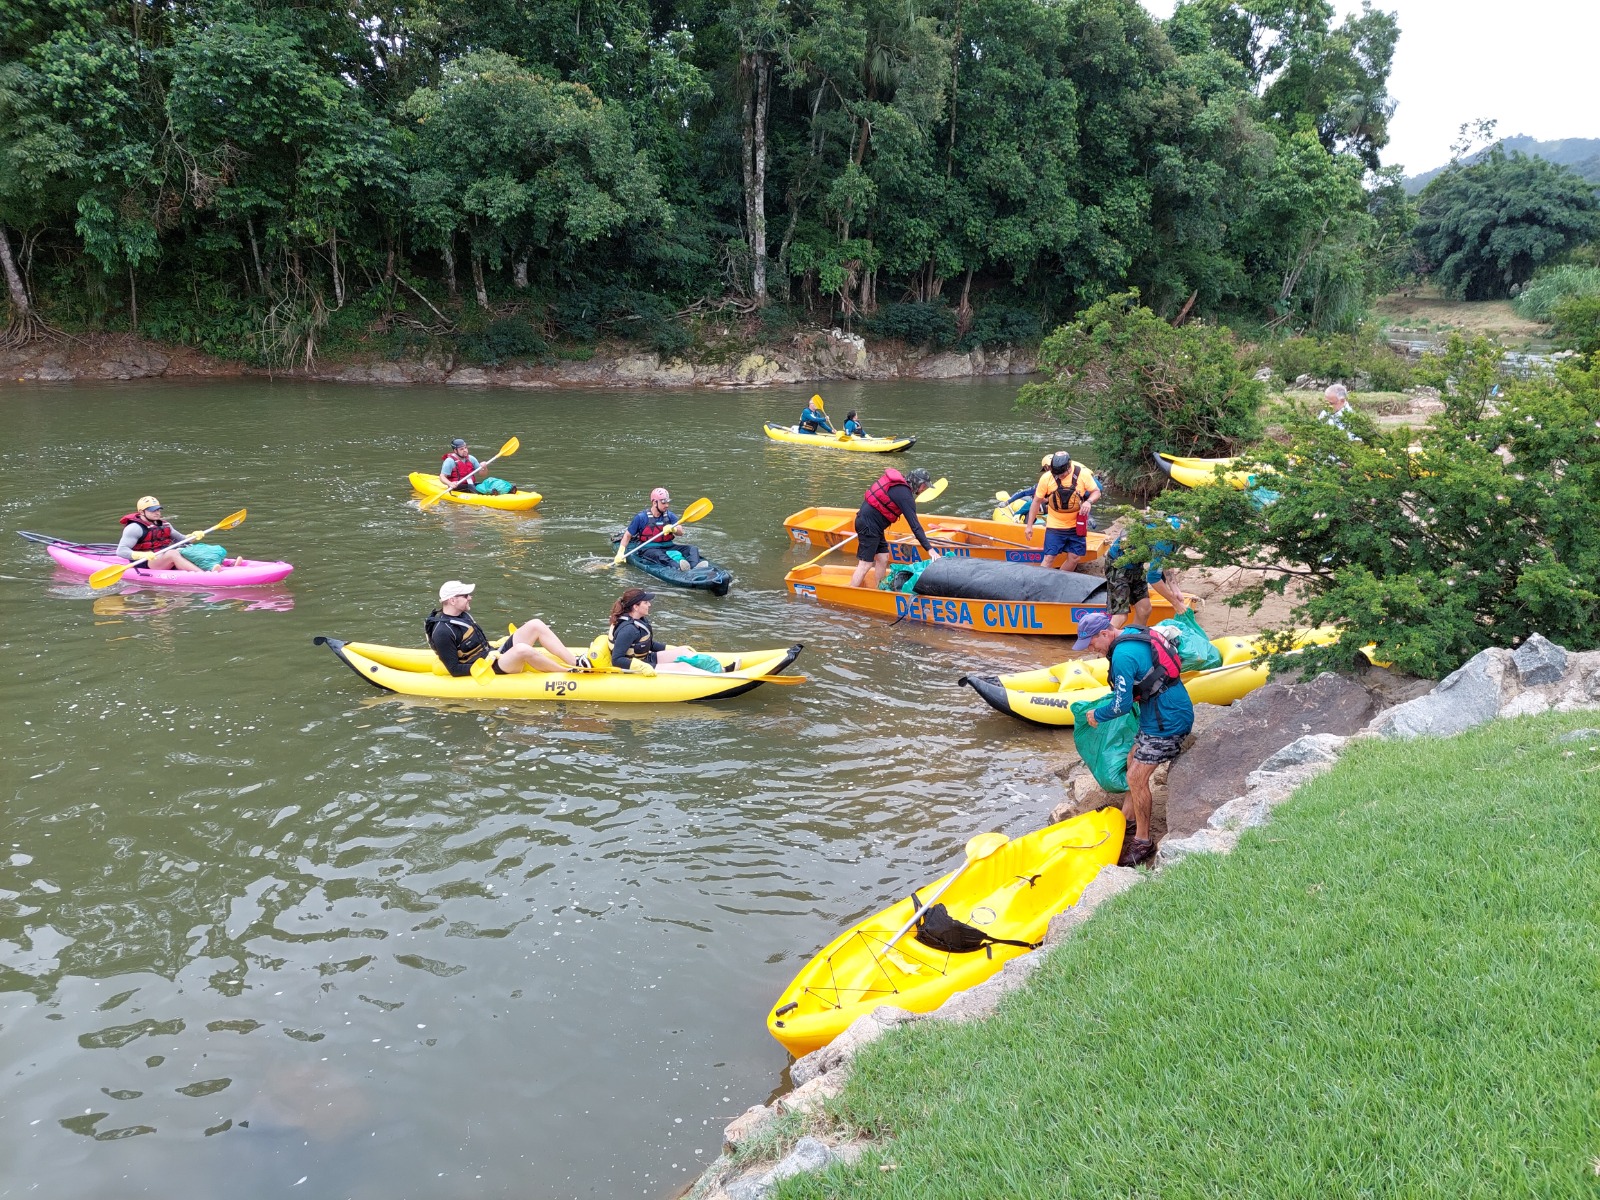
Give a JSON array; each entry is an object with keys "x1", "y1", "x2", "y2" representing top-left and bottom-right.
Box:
[{"x1": 0, "y1": 382, "x2": 1094, "y2": 1200}]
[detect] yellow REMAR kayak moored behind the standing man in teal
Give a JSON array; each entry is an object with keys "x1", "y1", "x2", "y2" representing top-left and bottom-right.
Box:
[{"x1": 957, "y1": 629, "x2": 1339, "y2": 726}]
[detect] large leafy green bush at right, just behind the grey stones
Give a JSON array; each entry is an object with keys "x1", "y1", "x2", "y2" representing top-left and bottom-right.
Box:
[{"x1": 1171, "y1": 347, "x2": 1600, "y2": 678}]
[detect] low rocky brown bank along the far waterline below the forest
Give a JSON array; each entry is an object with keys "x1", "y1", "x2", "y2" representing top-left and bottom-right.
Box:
[{"x1": 0, "y1": 330, "x2": 1035, "y2": 389}]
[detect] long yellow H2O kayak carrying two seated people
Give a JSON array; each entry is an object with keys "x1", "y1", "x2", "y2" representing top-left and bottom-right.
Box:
[{"x1": 312, "y1": 637, "x2": 803, "y2": 704}]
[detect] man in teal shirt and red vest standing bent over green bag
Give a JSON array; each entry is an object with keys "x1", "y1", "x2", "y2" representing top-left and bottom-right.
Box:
[{"x1": 1072, "y1": 613, "x2": 1195, "y2": 867}]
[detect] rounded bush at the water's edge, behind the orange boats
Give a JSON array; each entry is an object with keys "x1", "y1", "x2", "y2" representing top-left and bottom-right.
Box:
[{"x1": 1019, "y1": 291, "x2": 1266, "y2": 499}]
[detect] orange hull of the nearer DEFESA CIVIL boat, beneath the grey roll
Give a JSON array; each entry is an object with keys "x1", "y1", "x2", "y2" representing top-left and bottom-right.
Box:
[{"x1": 784, "y1": 560, "x2": 1173, "y2": 637}]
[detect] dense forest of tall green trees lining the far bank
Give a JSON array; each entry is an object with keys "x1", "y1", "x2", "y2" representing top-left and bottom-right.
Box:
[{"x1": 0, "y1": 0, "x2": 1411, "y2": 362}]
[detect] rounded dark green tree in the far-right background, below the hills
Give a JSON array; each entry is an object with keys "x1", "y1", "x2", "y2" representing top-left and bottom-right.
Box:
[{"x1": 1414, "y1": 147, "x2": 1600, "y2": 299}]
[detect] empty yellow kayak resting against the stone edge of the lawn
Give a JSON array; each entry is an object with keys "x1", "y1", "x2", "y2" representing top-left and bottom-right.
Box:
[{"x1": 766, "y1": 808, "x2": 1125, "y2": 1058}]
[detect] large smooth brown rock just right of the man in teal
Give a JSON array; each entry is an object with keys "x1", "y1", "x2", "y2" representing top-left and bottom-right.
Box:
[{"x1": 1166, "y1": 674, "x2": 1376, "y2": 838}]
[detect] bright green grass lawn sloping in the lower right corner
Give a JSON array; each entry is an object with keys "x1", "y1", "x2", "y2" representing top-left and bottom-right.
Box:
[{"x1": 778, "y1": 712, "x2": 1600, "y2": 1200}]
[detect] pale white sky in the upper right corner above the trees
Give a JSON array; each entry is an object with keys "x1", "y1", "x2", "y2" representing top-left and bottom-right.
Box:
[{"x1": 1141, "y1": 0, "x2": 1600, "y2": 174}]
